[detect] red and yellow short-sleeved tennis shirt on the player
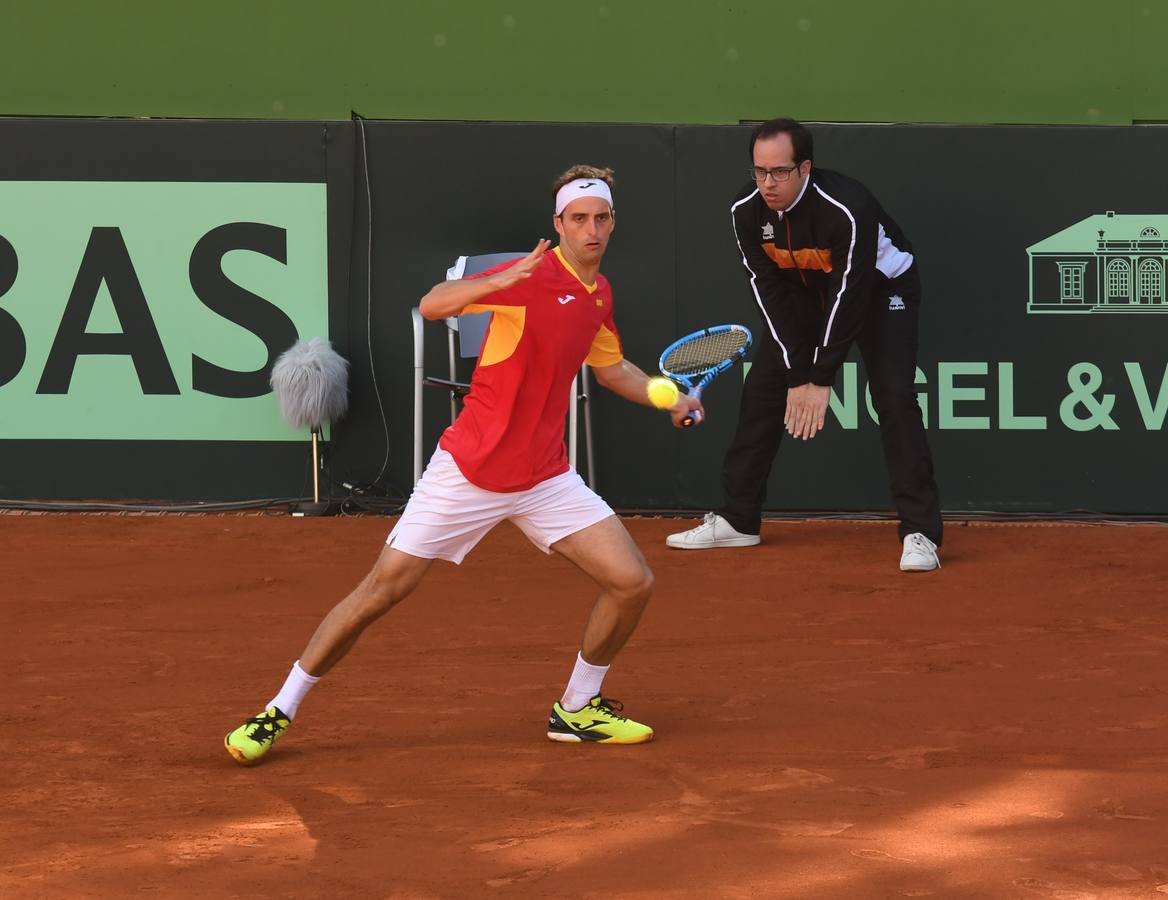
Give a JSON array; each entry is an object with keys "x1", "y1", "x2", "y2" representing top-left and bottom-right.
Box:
[{"x1": 438, "y1": 247, "x2": 624, "y2": 493}]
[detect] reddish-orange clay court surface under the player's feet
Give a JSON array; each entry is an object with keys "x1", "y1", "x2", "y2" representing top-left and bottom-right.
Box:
[{"x1": 0, "y1": 515, "x2": 1168, "y2": 900}]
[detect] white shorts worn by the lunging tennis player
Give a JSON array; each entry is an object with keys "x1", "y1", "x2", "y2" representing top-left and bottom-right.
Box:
[{"x1": 385, "y1": 447, "x2": 616, "y2": 564}]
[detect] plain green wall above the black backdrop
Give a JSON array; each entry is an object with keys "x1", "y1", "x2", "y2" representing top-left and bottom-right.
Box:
[{"x1": 0, "y1": 0, "x2": 1168, "y2": 124}]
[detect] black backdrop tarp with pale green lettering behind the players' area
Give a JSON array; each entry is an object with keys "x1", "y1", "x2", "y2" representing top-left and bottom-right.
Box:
[{"x1": 0, "y1": 119, "x2": 1168, "y2": 514}]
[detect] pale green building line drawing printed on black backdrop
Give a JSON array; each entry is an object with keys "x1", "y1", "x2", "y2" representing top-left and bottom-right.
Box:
[{"x1": 1026, "y1": 210, "x2": 1168, "y2": 315}]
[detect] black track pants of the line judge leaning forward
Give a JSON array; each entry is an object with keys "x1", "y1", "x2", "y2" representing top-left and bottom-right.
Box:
[{"x1": 718, "y1": 267, "x2": 941, "y2": 545}]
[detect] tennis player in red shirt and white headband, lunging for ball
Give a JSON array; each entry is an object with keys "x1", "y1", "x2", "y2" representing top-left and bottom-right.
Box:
[{"x1": 224, "y1": 166, "x2": 702, "y2": 766}]
